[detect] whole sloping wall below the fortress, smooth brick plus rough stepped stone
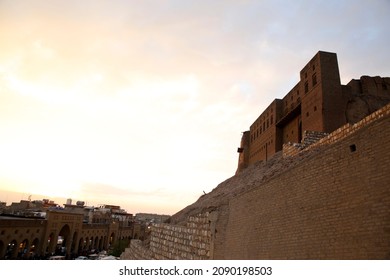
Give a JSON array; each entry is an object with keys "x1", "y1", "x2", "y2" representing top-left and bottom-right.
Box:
[{"x1": 122, "y1": 105, "x2": 390, "y2": 259}]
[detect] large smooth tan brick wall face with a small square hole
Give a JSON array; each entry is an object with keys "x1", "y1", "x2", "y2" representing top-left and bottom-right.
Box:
[{"x1": 221, "y1": 106, "x2": 390, "y2": 259}]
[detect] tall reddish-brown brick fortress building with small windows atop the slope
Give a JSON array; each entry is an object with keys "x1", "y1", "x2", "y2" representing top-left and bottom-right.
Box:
[{"x1": 237, "y1": 51, "x2": 347, "y2": 172}]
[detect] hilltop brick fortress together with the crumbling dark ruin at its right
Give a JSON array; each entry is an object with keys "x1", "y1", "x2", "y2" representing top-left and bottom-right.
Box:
[{"x1": 236, "y1": 51, "x2": 390, "y2": 173}]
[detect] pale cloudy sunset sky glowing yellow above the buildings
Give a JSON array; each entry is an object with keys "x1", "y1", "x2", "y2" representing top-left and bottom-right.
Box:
[{"x1": 0, "y1": 0, "x2": 390, "y2": 214}]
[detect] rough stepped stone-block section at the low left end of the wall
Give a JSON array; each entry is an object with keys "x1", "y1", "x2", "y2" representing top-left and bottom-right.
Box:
[{"x1": 121, "y1": 212, "x2": 217, "y2": 260}]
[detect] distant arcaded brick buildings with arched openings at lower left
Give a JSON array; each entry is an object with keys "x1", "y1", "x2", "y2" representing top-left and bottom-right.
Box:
[{"x1": 0, "y1": 200, "x2": 134, "y2": 259}]
